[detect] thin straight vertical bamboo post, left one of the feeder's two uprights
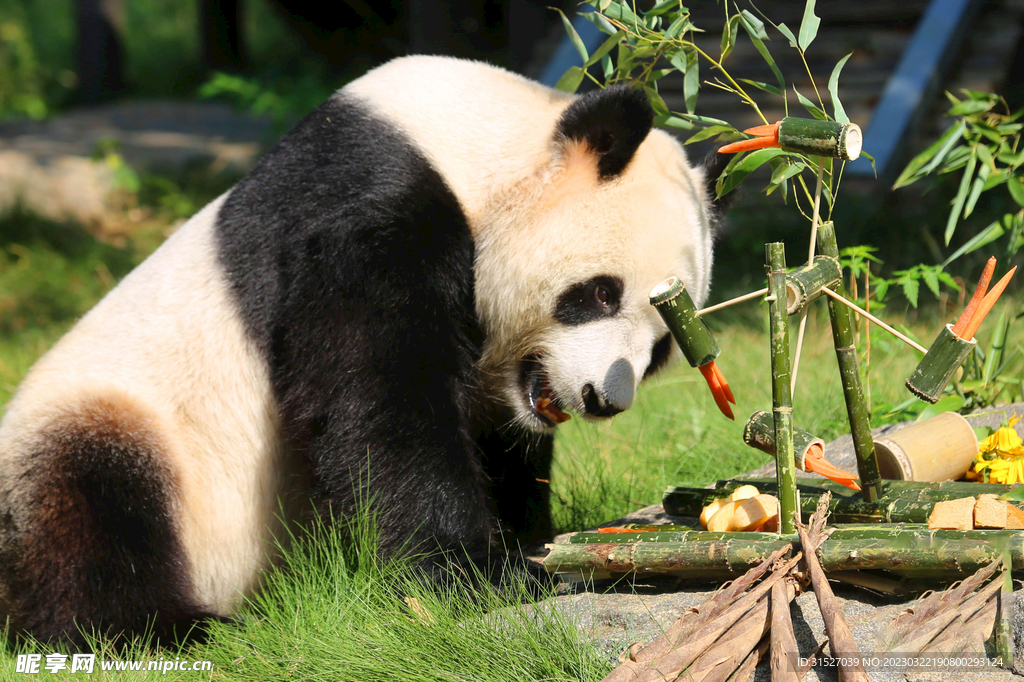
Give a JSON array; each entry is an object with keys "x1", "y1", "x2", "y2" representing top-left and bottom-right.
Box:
[{"x1": 765, "y1": 242, "x2": 800, "y2": 534}]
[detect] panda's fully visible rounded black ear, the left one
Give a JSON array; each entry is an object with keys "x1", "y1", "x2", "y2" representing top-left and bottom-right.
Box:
[{"x1": 557, "y1": 85, "x2": 654, "y2": 180}]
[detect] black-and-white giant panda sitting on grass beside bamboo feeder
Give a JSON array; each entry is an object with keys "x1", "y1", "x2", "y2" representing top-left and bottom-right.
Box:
[{"x1": 0, "y1": 56, "x2": 713, "y2": 642}]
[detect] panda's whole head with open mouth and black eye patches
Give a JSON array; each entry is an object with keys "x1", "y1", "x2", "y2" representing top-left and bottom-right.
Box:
[{"x1": 476, "y1": 86, "x2": 712, "y2": 431}]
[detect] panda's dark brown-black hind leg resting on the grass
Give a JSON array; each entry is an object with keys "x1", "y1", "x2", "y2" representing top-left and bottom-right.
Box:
[{"x1": 0, "y1": 395, "x2": 210, "y2": 646}]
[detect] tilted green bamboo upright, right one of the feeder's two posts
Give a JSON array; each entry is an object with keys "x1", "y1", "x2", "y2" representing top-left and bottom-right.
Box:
[{"x1": 818, "y1": 221, "x2": 882, "y2": 502}]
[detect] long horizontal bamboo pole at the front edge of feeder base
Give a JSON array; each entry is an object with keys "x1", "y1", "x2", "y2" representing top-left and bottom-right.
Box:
[{"x1": 544, "y1": 528, "x2": 1024, "y2": 580}]
